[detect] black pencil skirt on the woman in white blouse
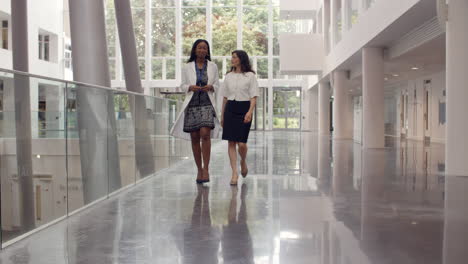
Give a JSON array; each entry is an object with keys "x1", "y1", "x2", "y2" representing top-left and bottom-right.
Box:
[{"x1": 223, "y1": 101, "x2": 252, "y2": 143}]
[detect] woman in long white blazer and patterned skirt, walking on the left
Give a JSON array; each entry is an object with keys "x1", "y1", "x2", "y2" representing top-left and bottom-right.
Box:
[{"x1": 171, "y1": 39, "x2": 220, "y2": 184}]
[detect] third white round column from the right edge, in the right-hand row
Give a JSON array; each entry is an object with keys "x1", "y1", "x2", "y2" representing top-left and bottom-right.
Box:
[{"x1": 333, "y1": 71, "x2": 353, "y2": 139}]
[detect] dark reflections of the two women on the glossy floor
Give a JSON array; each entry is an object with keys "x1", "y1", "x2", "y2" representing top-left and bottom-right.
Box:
[{"x1": 179, "y1": 185, "x2": 254, "y2": 264}]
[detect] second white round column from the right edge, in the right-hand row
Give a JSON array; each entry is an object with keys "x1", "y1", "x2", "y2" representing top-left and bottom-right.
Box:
[{"x1": 362, "y1": 48, "x2": 385, "y2": 148}]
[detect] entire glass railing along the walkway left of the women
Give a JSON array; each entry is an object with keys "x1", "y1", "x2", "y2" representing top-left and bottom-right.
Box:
[{"x1": 0, "y1": 69, "x2": 191, "y2": 246}]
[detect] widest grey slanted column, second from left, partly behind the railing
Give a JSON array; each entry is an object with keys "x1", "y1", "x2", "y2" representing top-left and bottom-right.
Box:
[{"x1": 68, "y1": 0, "x2": 123, "y2": 204}]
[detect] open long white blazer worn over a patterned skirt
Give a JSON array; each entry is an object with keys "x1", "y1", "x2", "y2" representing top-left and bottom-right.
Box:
[{"x1": 170, "y1": 61, "x2": 221, "y2": 140}]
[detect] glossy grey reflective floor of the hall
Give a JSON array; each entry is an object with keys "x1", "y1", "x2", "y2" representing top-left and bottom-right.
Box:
[{"x1": 0, "y1": 132, "x2": 468, "y2": 264}]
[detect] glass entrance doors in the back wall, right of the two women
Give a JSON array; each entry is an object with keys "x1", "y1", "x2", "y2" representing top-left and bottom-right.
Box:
[{"x1": 273, "y1": 87, "x2": 302, "y2": 130}]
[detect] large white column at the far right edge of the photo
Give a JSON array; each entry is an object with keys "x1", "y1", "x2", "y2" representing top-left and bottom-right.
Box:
[{"x1": 445, "y1": 0, "x2": 468, "y2": 176}]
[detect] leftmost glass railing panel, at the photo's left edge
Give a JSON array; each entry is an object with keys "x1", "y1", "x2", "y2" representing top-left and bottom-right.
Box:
[{"x1": 0, "y1": 74, "x2": 67, "y2": 243}]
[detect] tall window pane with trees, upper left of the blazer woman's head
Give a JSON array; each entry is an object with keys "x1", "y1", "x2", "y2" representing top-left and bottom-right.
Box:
[{"x1": 152, "y1": 8, "x2": 176, "y2": 57}]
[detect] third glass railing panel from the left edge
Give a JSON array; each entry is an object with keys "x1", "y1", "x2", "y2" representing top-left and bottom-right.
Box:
[{"x1": 113, "y1": 91, "x2": 136, "y2": 189}]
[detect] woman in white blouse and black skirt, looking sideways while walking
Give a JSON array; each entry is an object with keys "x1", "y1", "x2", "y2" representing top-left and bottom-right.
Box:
[{"x1": 221, "y1": 50, "x2": 258, "y2": 186}]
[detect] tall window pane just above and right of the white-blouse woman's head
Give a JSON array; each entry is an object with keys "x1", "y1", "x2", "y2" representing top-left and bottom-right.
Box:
[{"x1": 242, "y1": 7, "x2": 268, "y2": 56}]
